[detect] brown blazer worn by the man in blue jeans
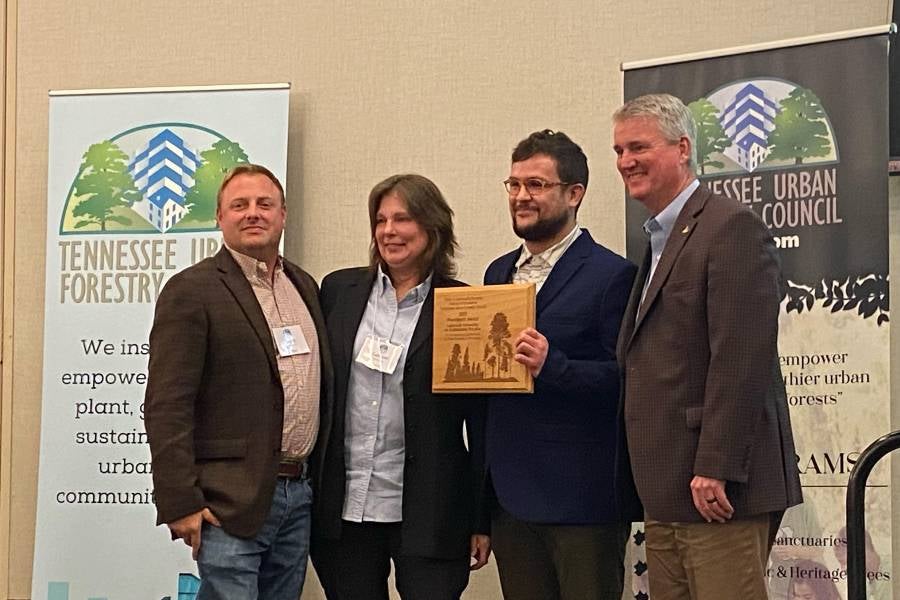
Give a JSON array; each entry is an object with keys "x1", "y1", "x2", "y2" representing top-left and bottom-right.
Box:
[{"x1": 144, "y1": 247, "x2": 332, "y2": 537}]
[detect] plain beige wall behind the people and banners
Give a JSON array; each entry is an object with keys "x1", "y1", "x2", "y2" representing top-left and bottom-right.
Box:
[{"x1": 0, "y1": 0, "x2": 897, "y2": 599}]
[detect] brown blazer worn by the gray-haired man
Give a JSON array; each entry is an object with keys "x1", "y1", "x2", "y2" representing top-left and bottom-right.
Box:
[{"x1": 617, "y1": 185, "x2": 802, "y2": 522}]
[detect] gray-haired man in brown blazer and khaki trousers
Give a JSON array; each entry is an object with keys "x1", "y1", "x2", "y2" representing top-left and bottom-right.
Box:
[{"x1": 613, "y1": 94, "x2": 801, "y2": 600}]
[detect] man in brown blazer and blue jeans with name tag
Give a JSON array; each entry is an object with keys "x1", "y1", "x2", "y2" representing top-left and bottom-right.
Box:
[{"x1": 145, "y1": 165, "x2": 331, "y2": 600}]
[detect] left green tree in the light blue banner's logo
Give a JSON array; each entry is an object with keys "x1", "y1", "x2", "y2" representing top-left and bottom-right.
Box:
[{"x1": 72, "y1": 140, "x2": 141, "y2": 231}]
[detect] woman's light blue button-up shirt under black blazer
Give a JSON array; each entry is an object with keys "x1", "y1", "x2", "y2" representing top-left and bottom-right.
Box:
[{"x1": 342, "y1": 268, "x2": 431, "y2": 523}]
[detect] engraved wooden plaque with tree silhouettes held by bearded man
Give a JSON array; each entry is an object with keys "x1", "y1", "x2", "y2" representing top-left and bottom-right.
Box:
[{"x1": 431, "y1": 283, "x2": 535, "y2": 393}]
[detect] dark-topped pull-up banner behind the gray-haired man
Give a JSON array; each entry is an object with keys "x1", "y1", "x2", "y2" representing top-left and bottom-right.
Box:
[{"x1": 623, "y1": 27, "x2": 893, "y2": 600}]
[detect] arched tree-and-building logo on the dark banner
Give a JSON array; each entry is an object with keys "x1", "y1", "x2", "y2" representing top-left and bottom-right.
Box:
[{"x1": 689, "y1": 78, "x2": 838, "y2": 175}]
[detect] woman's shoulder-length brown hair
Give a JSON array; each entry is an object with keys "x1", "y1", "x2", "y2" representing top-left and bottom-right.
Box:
[{"x1": 369, "y1": 173, "x2": 459, "y2": 279}]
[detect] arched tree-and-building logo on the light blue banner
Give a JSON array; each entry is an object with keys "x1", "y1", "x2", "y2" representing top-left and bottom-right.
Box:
[{"x1": 59, "y1": 123, "x2": 249, "y2": 235}]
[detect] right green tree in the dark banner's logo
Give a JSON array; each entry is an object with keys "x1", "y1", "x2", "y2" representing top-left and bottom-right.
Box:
[{"x1": 766, "y1": 87, "x2": 831, "y2": 165}]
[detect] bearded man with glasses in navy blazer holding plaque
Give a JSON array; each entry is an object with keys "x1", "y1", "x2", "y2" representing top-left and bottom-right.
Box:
[{"x1": 484, "y1": 130, "x2": 637, "y2": 600}]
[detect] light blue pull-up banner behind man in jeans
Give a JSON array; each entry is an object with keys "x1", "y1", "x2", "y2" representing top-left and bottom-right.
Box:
[{"x1": 31, "y1": 84, "x2": 289, "y2": 600}]
